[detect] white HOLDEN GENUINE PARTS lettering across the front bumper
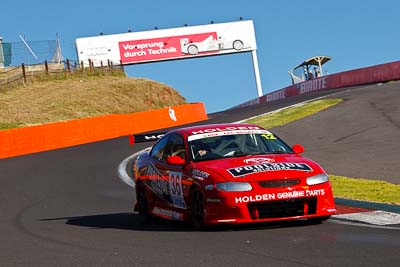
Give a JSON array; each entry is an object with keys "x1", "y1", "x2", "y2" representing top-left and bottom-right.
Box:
[{"x1": 235, "y1": 189, "x2": 325, "y2": 204}]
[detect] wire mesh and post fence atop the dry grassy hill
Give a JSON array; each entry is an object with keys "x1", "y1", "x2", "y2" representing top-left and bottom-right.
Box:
[{"x1": 0, "y1": 35, "x2": 124, "y2": 89}]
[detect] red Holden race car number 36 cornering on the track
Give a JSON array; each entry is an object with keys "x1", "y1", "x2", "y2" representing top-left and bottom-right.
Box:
[{"x1": 131, "y1": 123, "x2": 336, "y2": 228}]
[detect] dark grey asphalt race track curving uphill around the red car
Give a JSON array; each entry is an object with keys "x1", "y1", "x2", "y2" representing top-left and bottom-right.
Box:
[{"x1": 0, "y1": 83, "x2": 400, "y2": 266}]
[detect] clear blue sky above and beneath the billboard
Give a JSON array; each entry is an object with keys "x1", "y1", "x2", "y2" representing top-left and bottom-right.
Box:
[{"x1": 0, "y1": 0, "x2": 400, "y2": 112}]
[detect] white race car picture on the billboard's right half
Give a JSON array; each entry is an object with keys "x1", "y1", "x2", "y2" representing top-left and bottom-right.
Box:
[{"x1": 180, "y1": 35, "x2": 249, "y2": 55}]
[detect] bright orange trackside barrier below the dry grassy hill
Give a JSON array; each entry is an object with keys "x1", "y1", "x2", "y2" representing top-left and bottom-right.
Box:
[{"x1": 0, "y1": 103, "x2": 207, "y2": 158}]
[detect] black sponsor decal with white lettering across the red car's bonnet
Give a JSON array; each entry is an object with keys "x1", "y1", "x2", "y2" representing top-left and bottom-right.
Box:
[{"x1": 228, "y1": 162, "x2": 312, "y2": 177}]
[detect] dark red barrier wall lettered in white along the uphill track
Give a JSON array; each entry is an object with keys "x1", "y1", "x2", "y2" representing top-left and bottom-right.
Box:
[{"x1": 234, "y1": 61, "x2": 400, "y2": 108}]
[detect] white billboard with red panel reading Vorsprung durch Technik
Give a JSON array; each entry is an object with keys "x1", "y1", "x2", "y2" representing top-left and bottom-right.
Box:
[{"x1": 76, "y1": 20, "x2": 257, "y2": 66}]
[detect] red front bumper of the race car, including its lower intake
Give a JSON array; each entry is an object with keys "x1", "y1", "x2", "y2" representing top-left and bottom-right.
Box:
[{"x1": 205, "y1": 182, "x2": 336, "y2": 224}]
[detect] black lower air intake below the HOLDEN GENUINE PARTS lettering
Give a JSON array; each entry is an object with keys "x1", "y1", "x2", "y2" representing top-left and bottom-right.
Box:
[{"x1": 247, "y1": 197, "x2": 317, "y2": 220}]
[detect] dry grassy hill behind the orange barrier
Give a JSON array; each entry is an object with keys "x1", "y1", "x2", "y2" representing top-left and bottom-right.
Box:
[{"x1": 0, "y1": 75, "x2": 186, "y2": 129}]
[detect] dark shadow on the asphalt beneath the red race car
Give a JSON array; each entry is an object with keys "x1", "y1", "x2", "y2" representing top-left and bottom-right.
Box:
[{"x1": 40, "y1": 213, "x2": 319, "y2": 232}]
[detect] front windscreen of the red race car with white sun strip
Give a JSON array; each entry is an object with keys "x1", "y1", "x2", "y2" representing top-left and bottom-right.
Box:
[{"x1": 188, "y1": 130, "x2": 293, "y2": 161}]
